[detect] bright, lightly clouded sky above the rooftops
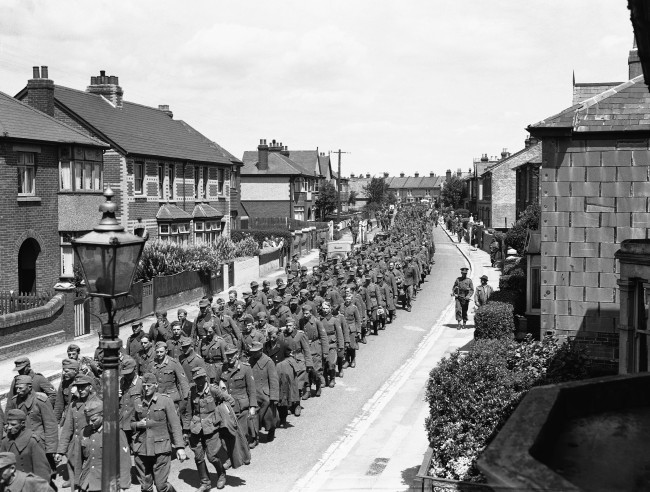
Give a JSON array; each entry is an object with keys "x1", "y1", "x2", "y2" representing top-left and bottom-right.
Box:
[{"x1": 0, "y1": 0, "x2": 633, "y2": 175}]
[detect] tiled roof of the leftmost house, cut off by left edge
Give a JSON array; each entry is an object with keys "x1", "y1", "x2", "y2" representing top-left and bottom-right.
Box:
[{"x1": 0, "y1": 92, "x2": 108, "y2": 148}]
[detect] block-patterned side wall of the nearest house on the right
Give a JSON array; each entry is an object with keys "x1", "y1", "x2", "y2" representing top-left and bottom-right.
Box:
[{"x1": 541, "y1": 138, "x2": 650, "y2": 360}]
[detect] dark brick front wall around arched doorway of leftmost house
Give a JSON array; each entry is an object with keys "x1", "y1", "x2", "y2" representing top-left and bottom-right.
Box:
[{"x1": 0, "y1": 139, "x2": 61, "y2": 291}]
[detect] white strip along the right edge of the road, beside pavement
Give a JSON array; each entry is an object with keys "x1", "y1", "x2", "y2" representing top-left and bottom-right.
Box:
[{"x1": 291, "y1": 301, "x2": 455, "y2": 492}]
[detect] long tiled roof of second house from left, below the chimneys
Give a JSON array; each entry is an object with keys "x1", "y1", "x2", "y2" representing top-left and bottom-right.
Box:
[{"x1": 49, "y1": 85, "x2": 231, "y2": 164}]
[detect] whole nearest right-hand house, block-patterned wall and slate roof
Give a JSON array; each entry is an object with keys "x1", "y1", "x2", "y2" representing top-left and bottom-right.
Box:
[{"x1": 528, "y1": 46, "x2": 650, "y2": 368}]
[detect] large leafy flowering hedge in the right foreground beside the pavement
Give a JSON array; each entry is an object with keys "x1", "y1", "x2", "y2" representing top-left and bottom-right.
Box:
[{"x1": 425, "y1": 337, "x2": 588, "y2": 482}]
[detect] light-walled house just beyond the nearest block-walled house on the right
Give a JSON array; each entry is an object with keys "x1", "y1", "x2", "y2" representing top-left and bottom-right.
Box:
[{"x1": 477, "y1": 141, "x2": 542, "y2": 229}]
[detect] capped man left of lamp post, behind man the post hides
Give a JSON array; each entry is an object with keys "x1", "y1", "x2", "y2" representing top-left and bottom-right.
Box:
[{"x1": 54, "y1": 374, "x2": 101, "y2": 490}]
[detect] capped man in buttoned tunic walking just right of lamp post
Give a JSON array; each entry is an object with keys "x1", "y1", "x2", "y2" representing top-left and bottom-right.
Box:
[{"x1": 131, "y1": 373, "x2": 187, "y2": 492}]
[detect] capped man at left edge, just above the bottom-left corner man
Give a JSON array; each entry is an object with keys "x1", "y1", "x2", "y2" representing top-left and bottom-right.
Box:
[{"x1": 0, "y1": 408, "x2": 51, "y2": 480}]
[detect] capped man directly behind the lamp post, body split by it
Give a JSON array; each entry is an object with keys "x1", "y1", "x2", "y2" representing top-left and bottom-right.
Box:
[{"x1": 79, "y1": 400, "x2": 131, "y2": 492}]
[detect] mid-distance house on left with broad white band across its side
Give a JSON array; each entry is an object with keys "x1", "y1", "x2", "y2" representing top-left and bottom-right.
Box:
[{"x1": 241, "y1": 139, "x2": 323, "y2": 220}]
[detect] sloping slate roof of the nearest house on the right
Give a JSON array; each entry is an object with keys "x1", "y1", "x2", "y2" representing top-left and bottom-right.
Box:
[{"x1": 528, "y1": 75, "x2": 650, "y2": 132}]
